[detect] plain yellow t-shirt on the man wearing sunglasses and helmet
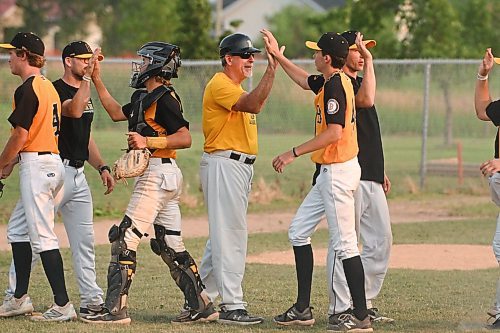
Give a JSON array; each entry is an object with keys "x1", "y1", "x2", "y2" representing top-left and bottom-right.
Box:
[{"x1": 202, "y1": 73, "x2": 258, "y2": 155}]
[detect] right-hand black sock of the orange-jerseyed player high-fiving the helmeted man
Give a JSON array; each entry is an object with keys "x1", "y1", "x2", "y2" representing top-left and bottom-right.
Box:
[{"x1": 342, "y1": 256, "x2": 368, "y2": 320}]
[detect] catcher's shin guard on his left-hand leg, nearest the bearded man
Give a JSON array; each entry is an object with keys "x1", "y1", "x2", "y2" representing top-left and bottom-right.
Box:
[{"x1": 104, "y1": 216, "x2": 137, "y2": 314}]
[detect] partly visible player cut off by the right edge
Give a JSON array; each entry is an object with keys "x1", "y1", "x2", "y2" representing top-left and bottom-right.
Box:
[{"x1": 474, "y1": 48, "x2": 500, "y2": 330}]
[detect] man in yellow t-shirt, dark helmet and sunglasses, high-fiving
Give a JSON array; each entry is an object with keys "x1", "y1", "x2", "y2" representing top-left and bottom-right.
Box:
[{"x1": 200, "y1": 33, "x2": 279, "y2": 325}]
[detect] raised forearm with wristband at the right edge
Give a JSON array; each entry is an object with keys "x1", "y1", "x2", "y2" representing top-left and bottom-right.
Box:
[{"x1": 474, "y1": 48, "x2": 494, "y2": 121}]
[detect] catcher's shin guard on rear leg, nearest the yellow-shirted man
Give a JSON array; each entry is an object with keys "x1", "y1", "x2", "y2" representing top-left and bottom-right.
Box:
[{"x1": 151, "y1": 225, "x2": 210, "y2": 312}]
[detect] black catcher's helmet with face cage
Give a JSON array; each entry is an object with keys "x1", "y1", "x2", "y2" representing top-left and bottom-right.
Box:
[{"x1": 130, "y1": 42, "x2": 181, "y2": 89}]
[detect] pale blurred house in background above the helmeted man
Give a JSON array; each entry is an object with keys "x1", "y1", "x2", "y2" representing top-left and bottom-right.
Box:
[{"x1": 210, "y1": 0, "x2": 345, "y2": 39}]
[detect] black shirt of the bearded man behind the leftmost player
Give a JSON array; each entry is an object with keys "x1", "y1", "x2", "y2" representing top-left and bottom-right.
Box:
[{"x1": 53, "y1": 79, "x2": 94, "y2": 161}]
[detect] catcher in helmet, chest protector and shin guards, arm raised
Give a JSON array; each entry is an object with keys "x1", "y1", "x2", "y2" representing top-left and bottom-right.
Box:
[{"x1": 81, "y1": 42, "x2": 218, "y2": 324}]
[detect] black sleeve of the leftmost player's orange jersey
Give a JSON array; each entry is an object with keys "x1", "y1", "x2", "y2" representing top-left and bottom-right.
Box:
[{"x1": 8, "y1": 76, "x2": 39, "y2": 131}]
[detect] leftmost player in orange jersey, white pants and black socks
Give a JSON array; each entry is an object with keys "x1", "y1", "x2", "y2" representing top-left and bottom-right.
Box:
[{"x1": 0, "y1": 32, "x2": 76, "y2": 321}]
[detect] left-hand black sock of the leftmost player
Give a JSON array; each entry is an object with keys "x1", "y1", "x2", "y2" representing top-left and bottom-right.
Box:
[{"x1": 10, "y1": 242, "x2": 32, "y2": 298}]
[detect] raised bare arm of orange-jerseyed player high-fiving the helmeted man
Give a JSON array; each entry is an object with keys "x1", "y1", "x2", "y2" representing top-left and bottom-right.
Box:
[{"x1": 260, "y1": 29, "x2": 311, "y2": 90}]
